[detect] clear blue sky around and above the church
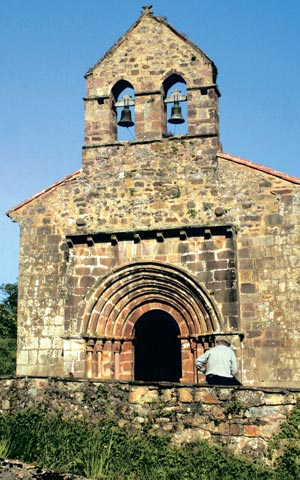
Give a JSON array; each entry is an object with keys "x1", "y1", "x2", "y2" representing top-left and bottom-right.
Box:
[{"x1": 0, "y1": 0, "x2": 300, "y2": 284}]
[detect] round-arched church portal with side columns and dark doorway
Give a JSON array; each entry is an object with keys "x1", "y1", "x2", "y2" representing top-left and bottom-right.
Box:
[{"x1": 78, "y1": 262, "x2": 222, "y2": 382}]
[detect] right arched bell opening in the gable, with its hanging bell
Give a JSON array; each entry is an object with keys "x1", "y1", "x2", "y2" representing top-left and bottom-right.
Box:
[{"x1": 163, "y1": 73, "x2": 188, "y2": 135}]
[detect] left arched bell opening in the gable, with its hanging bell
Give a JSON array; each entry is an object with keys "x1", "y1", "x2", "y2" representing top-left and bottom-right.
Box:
[{"x1": 112, "y1": 80, "x2": 135, "y2": 141}]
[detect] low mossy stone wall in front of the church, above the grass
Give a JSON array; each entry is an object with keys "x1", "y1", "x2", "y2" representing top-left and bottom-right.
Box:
[{"x1": 0, "y1": 377, "x2": 300, "y2": 458}]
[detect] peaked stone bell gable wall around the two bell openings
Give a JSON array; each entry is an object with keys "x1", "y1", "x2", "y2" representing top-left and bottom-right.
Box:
[{"x1": 85, "y1": 15, "x2": 219, "y2": 145}]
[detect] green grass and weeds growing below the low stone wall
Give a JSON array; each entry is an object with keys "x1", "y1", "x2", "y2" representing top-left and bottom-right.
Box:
[{"x1": 0, "y1": 406, "x2": 300, "y2": 480}]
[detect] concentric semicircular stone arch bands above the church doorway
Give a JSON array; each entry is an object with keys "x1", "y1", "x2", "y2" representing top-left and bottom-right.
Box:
[{"x1": 80, "y1": 262, "x2": 222, "y2": 338}]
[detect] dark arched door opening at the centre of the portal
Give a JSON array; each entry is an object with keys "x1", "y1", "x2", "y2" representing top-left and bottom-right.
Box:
[{"x1": 134, "y1": 310, "x2": 182, "y2": 382}]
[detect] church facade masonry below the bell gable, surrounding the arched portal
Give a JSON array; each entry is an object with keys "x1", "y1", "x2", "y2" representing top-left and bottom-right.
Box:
[{"x1": 13, "y1": 138, "x2": 300, "y2": 387}]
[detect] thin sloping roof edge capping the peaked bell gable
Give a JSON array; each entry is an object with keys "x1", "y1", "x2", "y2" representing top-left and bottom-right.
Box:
[{"x1": 84, "y1": 9, "x2": 217, "y2": 77}]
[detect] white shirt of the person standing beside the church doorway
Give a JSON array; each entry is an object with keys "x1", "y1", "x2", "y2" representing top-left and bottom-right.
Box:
[{"x1": 195, "y1": 345, "x2": 237, "y2": 378}]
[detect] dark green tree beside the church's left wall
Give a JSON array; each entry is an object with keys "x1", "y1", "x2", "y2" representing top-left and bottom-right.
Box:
[{"x1": 0, "y1": 283, "x2": 18, "y2": 375}]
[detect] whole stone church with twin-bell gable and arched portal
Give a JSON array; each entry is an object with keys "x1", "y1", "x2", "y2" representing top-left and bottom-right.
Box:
[{"x1": 7, "y1": 7, "x2": 300, "y2": 387}]
